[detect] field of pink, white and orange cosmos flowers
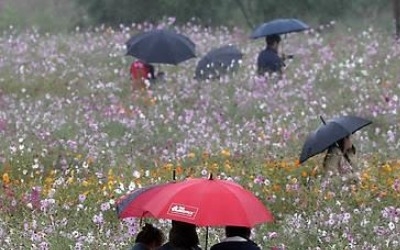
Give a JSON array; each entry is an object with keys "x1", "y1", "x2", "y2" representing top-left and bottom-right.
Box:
[{"x1": 0, "y1": 19, "x2": 400, "y2": 249}]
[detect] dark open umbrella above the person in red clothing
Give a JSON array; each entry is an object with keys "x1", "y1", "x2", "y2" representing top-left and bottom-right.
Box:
[{"x1": 126, "y1": 30, "x2": 196, "y2": 65}]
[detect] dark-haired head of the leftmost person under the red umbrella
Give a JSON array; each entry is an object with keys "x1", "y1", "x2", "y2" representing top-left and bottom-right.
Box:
[{"x1": 135, "y1": 223, "x2": 165, "y2": 249}]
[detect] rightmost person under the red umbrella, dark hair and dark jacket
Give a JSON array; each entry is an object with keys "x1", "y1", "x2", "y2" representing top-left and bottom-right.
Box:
[{"x1": 210, "y1": 226, "x2": 261, "y2": 250}]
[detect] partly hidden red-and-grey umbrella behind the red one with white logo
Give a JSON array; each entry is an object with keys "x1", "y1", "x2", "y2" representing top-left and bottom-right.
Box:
[{"x1": 117, "y1": 182, "x2": 174, "y2": 219}]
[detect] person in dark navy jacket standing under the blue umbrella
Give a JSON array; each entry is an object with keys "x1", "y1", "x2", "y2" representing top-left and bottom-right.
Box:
[{"x1": 257, "y1": 35, "x2": 285, "y2": 75}]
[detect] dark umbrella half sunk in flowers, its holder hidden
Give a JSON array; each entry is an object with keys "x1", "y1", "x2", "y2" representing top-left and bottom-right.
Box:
[{"x1": 195, "y1": 45, "x2": 243, "y2": 79}]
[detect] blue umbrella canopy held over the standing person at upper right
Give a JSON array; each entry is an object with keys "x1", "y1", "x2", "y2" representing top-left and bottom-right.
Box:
[{"x1": 250, "y1": 18, "x2": 310, "y2": 39}]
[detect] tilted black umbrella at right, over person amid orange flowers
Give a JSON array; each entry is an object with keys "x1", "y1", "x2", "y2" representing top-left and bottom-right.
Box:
[{"x1": 300, "y1": 116, "x2": 372, "y2": 163}]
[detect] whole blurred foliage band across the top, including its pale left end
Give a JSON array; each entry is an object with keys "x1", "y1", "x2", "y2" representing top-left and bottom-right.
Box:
[{"x1": 0, "y1": 0, "x2": 392, "y2": 31}]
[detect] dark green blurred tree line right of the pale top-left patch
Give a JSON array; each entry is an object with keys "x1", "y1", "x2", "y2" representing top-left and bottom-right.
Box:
[{"x1": 75, "y1": 0, "x2": 392, "y2": 28}]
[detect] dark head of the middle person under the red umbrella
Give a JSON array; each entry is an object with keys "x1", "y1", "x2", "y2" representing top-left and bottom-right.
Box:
[{"x1": 169, "y1": 221, "x2": 199, "y2": 249}]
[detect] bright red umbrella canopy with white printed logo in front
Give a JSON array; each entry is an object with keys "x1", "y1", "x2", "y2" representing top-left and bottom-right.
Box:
[{"x1": 139, "y1": 178, "x2": 273, "y2": 227}]
